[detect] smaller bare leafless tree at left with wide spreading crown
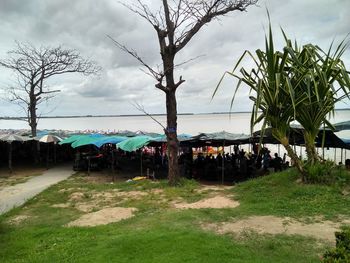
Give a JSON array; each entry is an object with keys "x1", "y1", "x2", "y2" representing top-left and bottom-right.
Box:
[{"x1": 0, "y1": 42, "x2": 100, "y2": 137}]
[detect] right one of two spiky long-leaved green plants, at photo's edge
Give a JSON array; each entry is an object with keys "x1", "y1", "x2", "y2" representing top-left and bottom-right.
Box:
[{"x1": 286, "y1": 41, "x2": 350, "y2": 164}]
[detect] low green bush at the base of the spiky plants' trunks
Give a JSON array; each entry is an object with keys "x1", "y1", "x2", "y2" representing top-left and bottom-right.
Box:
[{"x1": 305, "y1": 161, "x2": 350, "y2": 186}]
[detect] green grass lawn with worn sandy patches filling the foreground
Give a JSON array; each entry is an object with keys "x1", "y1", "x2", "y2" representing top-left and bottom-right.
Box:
[{"x1": 0, "y1": 170, "x2": 350, "y2": 263}]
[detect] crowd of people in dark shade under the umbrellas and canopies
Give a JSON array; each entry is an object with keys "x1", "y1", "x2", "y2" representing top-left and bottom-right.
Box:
[{"x1": 70, "y1": 143, "x2": 289, "y2": 181}]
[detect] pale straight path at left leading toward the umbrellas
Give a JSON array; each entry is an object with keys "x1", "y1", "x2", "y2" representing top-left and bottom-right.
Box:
[{"x1": 0, "y1": 165, "x2": 73, "y2": 214}]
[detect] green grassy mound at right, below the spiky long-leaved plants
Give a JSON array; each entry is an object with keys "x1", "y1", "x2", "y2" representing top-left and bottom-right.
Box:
[{"x1": 234, "y1": 170, "x2": 350, "y2": 219}]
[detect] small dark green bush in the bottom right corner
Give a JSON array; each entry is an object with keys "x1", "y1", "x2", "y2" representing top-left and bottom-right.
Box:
[{"x1": 323, "y1": 227, "x2": 350, "y2": 263}]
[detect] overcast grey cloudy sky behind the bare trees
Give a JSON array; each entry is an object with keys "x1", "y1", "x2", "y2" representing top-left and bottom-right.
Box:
[{"x1": 0, "y1": 0, "x2": 350, "y2": 116}]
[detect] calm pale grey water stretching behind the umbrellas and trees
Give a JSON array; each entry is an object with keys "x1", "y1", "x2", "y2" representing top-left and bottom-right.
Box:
[{"x1": 0, "y1": 110, "x2": 350, "y2": 138}]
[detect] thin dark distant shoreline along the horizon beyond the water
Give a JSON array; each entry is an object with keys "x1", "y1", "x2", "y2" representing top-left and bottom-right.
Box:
[{"x1": 0, "y1": 108, "x2": 350, "y2": 121}]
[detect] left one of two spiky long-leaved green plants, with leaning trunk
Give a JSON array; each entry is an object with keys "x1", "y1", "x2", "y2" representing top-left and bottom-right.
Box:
[{"x1": 213, "y1": 16, "x2": 307, "y2": 178}]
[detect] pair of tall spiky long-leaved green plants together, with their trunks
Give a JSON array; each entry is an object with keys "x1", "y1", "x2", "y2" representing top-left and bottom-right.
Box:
[{"x1": 213, "y1": 13, "x2": 350, "y2": 182}]
